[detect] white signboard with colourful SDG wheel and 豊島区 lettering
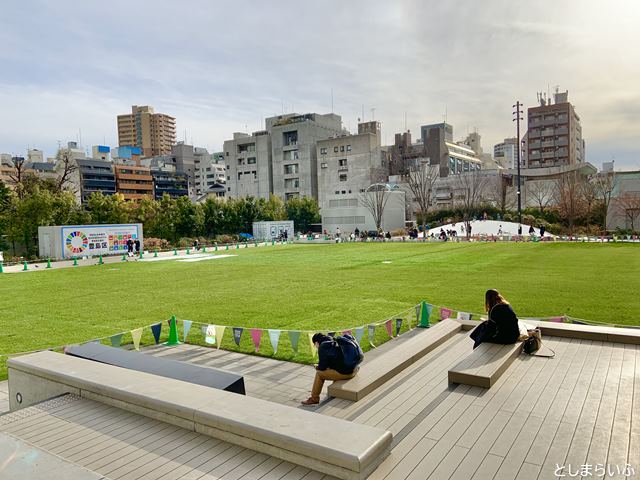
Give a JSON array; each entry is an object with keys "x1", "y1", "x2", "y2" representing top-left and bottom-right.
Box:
[{"x1": 61, "y1": 225, "x2": 142, "y2": 258}]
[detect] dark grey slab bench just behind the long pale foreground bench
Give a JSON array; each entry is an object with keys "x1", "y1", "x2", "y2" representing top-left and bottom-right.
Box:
[{"x1": 65, "y1": 343, "x2": 245, "y2": 395}]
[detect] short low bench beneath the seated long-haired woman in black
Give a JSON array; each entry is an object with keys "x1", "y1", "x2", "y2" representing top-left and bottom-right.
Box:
[{"x1": 449, "y1": 342, "x2": 523, "y2": 388}]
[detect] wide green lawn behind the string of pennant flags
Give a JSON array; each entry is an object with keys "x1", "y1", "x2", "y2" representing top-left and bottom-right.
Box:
[{"x1": 0, "y1": 243, "x2": 640, "y2": 377}]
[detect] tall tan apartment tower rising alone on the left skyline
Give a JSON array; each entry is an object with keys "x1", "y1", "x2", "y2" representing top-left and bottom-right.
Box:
[{"x1": 118, "y1": 105, "x2": 176, "y2": 157}]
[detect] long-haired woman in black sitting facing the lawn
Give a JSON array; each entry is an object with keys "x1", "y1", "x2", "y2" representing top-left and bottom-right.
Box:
[{"x1": 471, "y1": 289, "x2": 520, "y2": 349}]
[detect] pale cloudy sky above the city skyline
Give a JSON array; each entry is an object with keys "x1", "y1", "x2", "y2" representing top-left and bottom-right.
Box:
[{"x1": 0, "y1": 0, "x2": 640, "y2": 168}]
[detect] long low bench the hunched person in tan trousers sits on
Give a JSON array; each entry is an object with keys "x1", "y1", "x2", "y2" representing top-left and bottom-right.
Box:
[{"x1": 328, "y1": 319, "x2": 462, "y2": 402}]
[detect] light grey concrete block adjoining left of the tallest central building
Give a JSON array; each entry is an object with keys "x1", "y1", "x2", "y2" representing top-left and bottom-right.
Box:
[{"x1": 223, "y1": 130, "x2": 272, "y2": 199}]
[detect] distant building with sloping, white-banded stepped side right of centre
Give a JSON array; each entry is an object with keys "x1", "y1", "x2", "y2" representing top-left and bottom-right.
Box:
[{"x1": 420, "y1": 123, "x2": 482, "y2": 178}]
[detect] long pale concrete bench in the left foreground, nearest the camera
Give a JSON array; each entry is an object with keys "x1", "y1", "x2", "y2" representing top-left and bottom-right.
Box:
[{"x1": 7, "y1": 352, "x2": 392, "y2": 480}]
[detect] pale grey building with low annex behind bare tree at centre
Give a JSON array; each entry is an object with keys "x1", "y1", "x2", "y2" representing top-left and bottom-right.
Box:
[{"x1": 316, "y1": 122, "x2": 405, "y2": 233}]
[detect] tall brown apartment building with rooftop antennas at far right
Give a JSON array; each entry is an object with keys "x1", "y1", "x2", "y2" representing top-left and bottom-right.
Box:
[{"x1": 526, "y1": 91, "x2": 585, "y2": 168}]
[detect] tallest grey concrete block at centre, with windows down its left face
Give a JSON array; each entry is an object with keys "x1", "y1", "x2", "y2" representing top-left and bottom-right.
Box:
[{"x1": 266, "y1": 113, "x2": 345, "y2": 201}]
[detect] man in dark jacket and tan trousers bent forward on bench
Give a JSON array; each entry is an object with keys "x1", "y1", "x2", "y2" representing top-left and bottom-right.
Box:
[{"x1": 302, "y1": 333, "x2": 358, "y2": 406}]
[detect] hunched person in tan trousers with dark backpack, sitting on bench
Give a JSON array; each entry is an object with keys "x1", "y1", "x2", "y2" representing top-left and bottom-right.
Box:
[{"x1": 301, "y1": 333, "x2": 362, "y2": 406}]
